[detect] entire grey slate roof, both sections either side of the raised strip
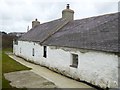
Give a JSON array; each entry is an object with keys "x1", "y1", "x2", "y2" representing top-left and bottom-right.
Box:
[{"x1": 21, "y1": 13, "x2": 120, "y2": 52}]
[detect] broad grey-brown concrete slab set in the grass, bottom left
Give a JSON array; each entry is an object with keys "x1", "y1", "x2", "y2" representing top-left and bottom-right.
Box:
[{"x1": 4, "y1": 70, "x2": 57, "y2": 88}]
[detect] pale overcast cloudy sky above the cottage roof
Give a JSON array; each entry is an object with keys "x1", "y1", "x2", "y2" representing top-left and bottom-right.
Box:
[{"x1": 0, "y1": 0, "x2": 119, "y2": 33}]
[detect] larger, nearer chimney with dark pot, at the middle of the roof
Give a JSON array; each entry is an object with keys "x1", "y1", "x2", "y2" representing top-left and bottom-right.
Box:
[{"x1": 62, "y1": 4, "x2": 74, "y2": 21}]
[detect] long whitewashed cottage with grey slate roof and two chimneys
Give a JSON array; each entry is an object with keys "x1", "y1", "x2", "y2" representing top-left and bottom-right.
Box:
[{"x1": 13, "y1": 4, "x2": 119, "y2": 88}]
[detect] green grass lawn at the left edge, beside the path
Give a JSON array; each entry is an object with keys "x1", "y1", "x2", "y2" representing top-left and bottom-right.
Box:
[{"x1": 0, "y1": 49, "x2": 30, "y2": 90}]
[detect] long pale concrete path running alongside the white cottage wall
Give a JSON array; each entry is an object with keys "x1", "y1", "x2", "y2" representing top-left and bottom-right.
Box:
[{"x1": 9, "y1": 55, "x2": 95, "y2": 90}]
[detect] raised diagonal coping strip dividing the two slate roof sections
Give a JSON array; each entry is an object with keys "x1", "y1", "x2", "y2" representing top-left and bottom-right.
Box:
[{"x1": 40, "y1": 20, "x2": 69, "y2": 44}]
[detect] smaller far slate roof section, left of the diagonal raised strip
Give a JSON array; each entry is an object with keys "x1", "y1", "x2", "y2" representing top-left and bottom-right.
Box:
[{"x1": 19, "y1": 19, "x2": 68, "y2": 43}]
